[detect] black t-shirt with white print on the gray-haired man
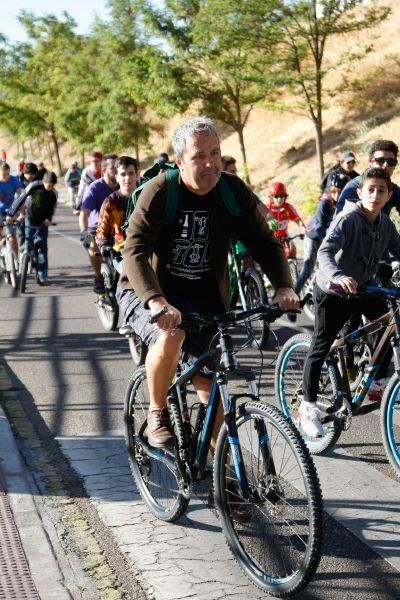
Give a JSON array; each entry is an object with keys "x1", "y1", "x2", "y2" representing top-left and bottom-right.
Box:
[{"x1": 166, "y1": 186, "x2": 223, "y2": 313}]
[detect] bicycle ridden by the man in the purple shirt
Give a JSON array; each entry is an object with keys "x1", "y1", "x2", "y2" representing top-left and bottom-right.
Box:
[{"x1": 95, "y1": 248, "x2": 122, "y2": 331}]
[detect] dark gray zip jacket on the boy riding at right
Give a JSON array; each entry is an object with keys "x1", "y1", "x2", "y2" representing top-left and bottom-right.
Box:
[{"x1": 317, "y1": 202, "x2": 400, "y2": 295}]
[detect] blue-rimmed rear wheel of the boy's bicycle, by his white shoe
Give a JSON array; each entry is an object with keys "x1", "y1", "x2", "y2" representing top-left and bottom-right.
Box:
[{"x1": 275, "y1": 333, "x2": 341, "y2": 454}]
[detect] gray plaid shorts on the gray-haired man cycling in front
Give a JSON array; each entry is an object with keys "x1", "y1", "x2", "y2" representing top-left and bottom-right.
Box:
[{"x1": 116, "y1": 285, "x2": 216, "y2": 378}]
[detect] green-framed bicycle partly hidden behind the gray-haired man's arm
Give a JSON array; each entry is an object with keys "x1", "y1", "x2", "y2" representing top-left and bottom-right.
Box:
[{"x1": 229, "y1": 242, "x2": 269, "y2": 349}]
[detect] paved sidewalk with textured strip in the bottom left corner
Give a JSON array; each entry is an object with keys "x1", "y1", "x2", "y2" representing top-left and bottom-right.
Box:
[{"x1": 0, "y1": 407, "x2": 71, "y2": 600}]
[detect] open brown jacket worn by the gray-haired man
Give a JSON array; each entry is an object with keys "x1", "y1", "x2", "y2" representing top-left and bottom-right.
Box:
[{"x1": 120, "y1": 173, "x2": 292, "y2": 309}]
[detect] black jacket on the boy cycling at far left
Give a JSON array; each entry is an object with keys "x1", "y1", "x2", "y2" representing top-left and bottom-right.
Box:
[{"x1": 8, "y1": 180, "x2": 57, "y2": 226}]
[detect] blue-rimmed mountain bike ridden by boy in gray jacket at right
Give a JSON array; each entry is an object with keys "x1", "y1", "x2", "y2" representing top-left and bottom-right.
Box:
[{"x1": 275, "y1": 285, "x2": 400, "y2": 476}]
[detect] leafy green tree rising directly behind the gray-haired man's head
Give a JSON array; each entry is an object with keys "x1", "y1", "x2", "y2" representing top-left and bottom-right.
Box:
[{"x1": 134, "y1": 0, "x2": 282, "y2": 183}]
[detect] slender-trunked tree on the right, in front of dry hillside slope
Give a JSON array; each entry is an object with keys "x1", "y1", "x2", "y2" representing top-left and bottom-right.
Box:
[{"x1": 256, "y1": 0, "x2": 390, "y2": 179}]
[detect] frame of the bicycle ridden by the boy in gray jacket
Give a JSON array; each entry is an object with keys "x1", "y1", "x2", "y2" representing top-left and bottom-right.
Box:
[{"x1": 327, "y1": 286, "x2": 400, "y2": 409}]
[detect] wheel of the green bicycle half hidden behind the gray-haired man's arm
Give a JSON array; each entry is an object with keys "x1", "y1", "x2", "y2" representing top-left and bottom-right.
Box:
[{"x1": 243, "y1": 269, "x2": 269, "y2": 350}]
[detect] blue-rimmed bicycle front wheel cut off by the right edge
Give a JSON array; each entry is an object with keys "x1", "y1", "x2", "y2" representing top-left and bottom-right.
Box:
[{"x1": 381, "y1": 374, "x2": 400, "y2": 477}]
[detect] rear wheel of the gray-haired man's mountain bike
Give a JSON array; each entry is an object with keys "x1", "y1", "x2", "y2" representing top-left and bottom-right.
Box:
[{"x1": 124, "y1": 367, "x2": 189, "y2": 522}]
